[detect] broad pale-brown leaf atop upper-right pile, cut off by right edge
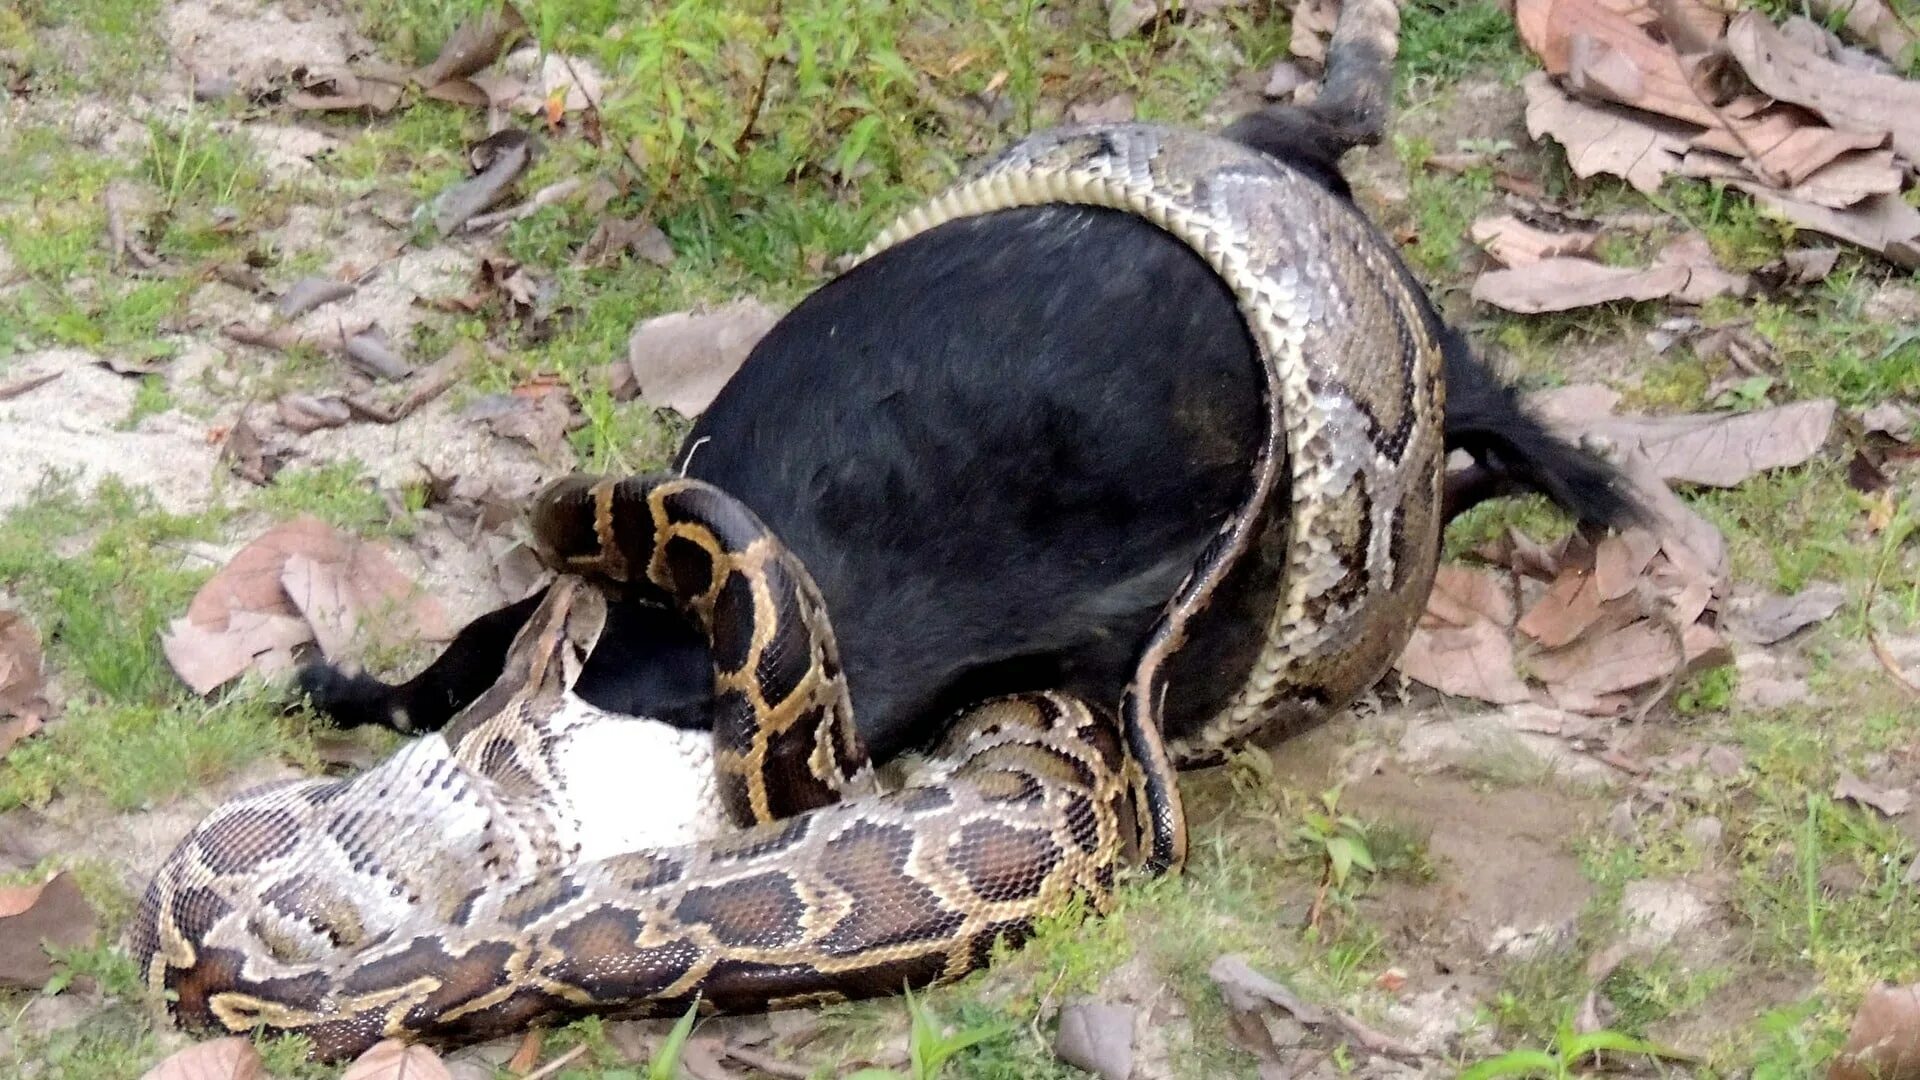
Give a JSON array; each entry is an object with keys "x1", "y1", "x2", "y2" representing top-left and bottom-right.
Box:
[{"x1": 1726, "y1": 12, "x2": 1920, "y2": 161}]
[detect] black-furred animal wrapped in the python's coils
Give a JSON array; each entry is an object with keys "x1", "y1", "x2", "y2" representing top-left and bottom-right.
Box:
[{"x1": 301, "y1": 94, "x2": 1632, "y2": 761}]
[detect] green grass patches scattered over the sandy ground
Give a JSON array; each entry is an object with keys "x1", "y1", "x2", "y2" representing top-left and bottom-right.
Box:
[{"x1": 0, "y1": 0, "x2": 1920, "y2": 1080}]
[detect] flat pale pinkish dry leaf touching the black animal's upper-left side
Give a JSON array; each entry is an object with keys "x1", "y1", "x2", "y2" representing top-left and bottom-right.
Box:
[{"x1": 626, "y1": 300, "x2": 781, "y2": 419}]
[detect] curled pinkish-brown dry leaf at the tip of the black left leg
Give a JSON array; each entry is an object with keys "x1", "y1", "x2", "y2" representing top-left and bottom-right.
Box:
[{"x1": 161, "y1": 517, "x2": 451, "y2": 694}]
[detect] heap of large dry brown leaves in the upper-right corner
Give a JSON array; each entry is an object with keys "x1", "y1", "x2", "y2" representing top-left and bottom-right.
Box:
[{"x1": 1515, "y1": 0, "x2": 1920, "y2": 267}]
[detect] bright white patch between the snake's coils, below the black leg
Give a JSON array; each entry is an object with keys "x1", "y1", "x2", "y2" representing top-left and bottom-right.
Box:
[{"x1": 555, "y1": 694, "x2": 728, "y2": 861}]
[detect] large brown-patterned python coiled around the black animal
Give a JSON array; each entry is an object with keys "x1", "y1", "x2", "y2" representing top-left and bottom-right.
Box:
[{"x1": 131, "y1": 4, "x2": 1444, "y2": 1057}]
